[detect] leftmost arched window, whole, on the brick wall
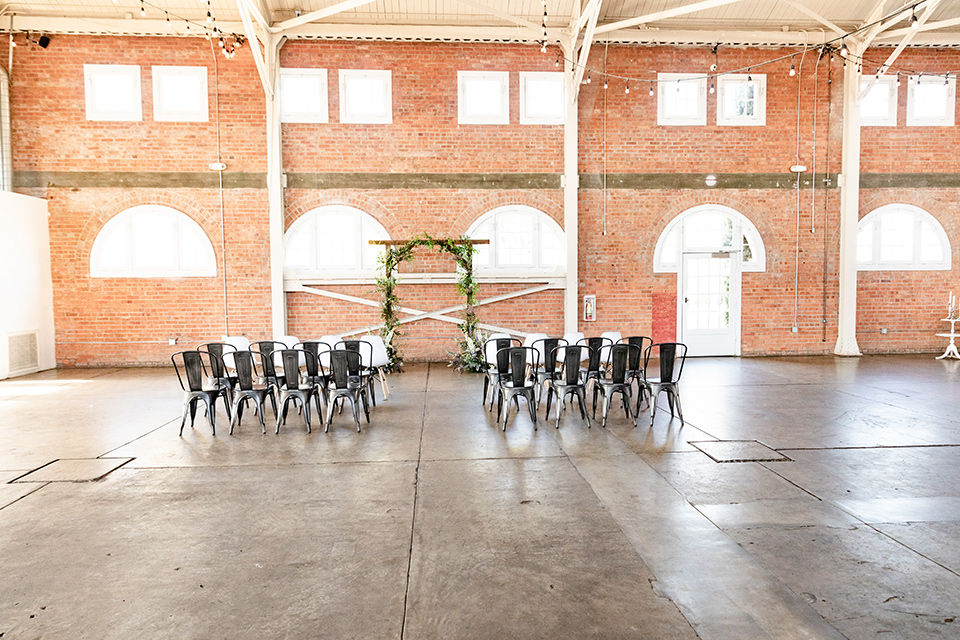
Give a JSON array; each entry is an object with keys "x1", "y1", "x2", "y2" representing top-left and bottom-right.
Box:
[{"x1": 90, "y1": 204, "x2": 217, "y2": 278}]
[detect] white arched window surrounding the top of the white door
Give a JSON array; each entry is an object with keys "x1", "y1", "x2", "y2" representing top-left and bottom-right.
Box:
[{"x1": 653, "y1": 204, "x2": 767, "y2": 273}]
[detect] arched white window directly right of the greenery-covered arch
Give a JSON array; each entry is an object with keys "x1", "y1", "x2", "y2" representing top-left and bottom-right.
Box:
[{"x1": 467, "y1": 205, "x2": 567, "y2": 274}]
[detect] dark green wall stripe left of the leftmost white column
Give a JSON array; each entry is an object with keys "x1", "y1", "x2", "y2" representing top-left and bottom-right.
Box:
[{"x1": 13, "y1": 171, "x2": 267, "y2": 189}]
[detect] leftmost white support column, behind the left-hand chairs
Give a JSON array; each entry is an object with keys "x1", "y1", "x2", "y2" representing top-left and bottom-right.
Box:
[{"x1": 262, "y1": 34, "x2": 287, "y2": 336}]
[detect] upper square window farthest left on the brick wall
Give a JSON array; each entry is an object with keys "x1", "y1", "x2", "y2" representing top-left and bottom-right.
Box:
[{"x1": 83, "y1": 64, "x2": 143, "y2": 122}]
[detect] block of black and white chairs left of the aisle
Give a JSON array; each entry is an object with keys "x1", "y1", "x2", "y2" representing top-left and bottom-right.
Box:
[{"x1": 171, "y1": 340, "x2": 380, "y2": 435}]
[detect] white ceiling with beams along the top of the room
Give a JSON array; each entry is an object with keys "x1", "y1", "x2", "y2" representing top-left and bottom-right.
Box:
[{"x1": 0, "y1": 0, "x2": 960, "y2": 51}]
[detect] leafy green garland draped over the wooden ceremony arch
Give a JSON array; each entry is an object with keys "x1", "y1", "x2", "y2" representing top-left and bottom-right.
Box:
[{"x1": 377, "y1": 233, "x2": 483, "y2": 371}]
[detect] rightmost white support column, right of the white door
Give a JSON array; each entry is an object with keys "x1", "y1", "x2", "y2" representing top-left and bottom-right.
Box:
[{"x1": 833, "y1": 51, "x2": 863, "y2": 356}]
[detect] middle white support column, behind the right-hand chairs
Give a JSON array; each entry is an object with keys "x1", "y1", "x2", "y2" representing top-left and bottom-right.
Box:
[{"x1": 563, "y1": 43, "x2": 580, "y2": 331}]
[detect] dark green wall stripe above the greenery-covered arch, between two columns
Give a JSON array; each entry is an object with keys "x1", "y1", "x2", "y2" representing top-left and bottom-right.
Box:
[{"x1": 287, "y1": 172, "x2": 560, "y2": 189}]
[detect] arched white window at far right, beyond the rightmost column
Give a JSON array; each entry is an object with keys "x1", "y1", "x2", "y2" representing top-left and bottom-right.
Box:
[{"x1": 857, "y1": 204, "x2": 950, "y2": 271}]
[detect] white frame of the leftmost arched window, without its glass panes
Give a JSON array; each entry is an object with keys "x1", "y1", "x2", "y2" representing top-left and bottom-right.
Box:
[{"x1": 90, "y1": 204, "x2": 217, "y2": 278}]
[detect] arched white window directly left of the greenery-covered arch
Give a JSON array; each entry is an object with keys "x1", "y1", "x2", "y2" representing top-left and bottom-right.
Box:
[{"x1": 283, "y1": 204, "x2": 390, "y2": 279}]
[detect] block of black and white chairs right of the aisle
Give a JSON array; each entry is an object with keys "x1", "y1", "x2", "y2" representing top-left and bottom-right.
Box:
[{"x1": 482, "y1": 336, "x2": 687, "y2": 430}]
